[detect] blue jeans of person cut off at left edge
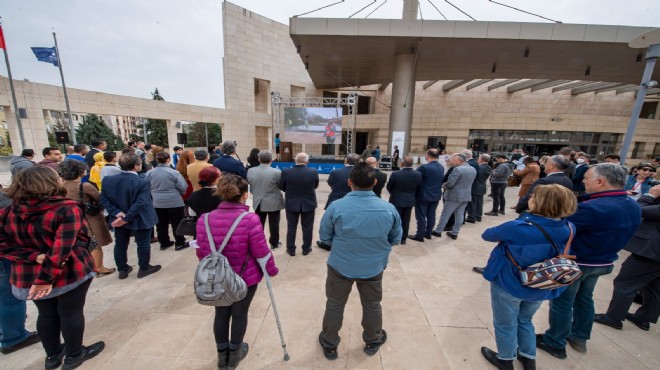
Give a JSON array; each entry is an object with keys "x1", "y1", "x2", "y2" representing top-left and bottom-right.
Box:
[{"x1": 0, "y1": 258, "x2": 30, "y2": 348}]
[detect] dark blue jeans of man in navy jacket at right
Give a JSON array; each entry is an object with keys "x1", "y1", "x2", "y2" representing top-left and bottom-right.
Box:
[{"x1": 543, "y1": 265, "x2": 614, "y2": 348}]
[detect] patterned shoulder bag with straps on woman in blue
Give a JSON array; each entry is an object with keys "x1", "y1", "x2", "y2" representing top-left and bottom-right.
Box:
[{"x1": 505, "y1": 220, "x2": 582, "y2": 289}]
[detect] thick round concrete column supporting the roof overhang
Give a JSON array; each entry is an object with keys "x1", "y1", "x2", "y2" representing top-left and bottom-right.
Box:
[{"x1": 388, "y1": 53, "x2": 415, "y2": 158}]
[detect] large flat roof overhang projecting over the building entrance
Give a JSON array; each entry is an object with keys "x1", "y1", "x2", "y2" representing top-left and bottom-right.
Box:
[{"x1": 289, "y1": 18, "x2": 660, "y2": 89}]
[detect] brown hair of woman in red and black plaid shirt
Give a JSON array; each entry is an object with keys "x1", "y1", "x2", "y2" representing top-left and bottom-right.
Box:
[{"x1": 6, "y1": 167, "x2": 67, "y2": 203}]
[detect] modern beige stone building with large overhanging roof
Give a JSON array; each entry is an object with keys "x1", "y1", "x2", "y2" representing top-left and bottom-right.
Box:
[{"x1": 0, "y1": 2, "x2": 660, "y2": 163}]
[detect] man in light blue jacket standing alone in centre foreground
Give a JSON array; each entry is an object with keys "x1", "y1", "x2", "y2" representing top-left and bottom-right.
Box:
[{"x1": 319, "y1": 163, "x2": 402, "y2": 360}]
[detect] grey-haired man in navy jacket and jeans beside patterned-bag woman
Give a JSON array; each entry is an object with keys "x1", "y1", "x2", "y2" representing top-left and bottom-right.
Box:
[{"x1": 536, "y1": 163, "x2": 642, "y2": 359}]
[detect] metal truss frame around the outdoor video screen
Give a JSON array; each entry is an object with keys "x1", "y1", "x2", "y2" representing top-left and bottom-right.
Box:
[{"x1": 270, "y1": 91, "x2": 358, "y2": 154}]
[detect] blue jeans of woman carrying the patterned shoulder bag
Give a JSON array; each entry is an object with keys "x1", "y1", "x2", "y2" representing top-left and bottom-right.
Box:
[{"x1": 490, "y1": 283, "x2": 543, "y2": 360}]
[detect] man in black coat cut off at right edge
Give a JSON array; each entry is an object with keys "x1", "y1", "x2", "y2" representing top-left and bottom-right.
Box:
[{"x1": 594, "y1": 185, "x2": 660, "y2": 330}]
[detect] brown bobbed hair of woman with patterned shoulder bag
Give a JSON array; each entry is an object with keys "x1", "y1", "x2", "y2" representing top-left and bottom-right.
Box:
[{"x1": 530, "y1": 184, "x2": 577, "y2": 218}]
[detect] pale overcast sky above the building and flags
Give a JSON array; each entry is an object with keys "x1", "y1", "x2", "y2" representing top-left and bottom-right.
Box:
[{"x1": 0, "y1": 0, "x2": 660, "y2": 107}]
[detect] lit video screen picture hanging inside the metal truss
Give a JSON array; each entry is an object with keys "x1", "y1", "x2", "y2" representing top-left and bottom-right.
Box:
[{"x1": 282, "y1": 107, "x2": 342, "y2": 144}]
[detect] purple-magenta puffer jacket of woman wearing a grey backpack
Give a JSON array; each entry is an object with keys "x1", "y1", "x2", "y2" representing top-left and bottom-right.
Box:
[{"x1": 197, "y1": 202, "x2": 279, "y2": 287}]
